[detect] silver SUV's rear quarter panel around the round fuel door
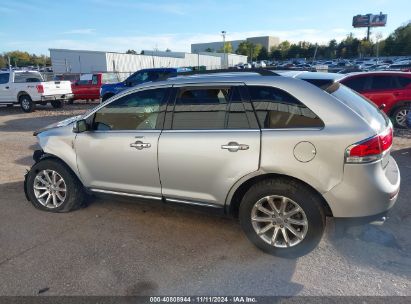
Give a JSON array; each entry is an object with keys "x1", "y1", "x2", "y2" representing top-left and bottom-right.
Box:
[{"x1": 240, "y1": 77, "x2": 375, "y2": 193}]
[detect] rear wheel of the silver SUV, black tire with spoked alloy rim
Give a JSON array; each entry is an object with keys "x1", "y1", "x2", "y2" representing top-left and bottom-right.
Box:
[{"x1": 239, "y1": 178, "x2": 325, "y2": 258}]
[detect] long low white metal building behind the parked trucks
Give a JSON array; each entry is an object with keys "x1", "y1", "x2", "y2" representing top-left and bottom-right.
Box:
[{"x1": 50, "y1": 49, "x2": 247, "y2": 74}]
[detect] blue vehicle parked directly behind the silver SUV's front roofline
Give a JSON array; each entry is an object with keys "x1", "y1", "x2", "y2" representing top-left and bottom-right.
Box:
[{"x1": 100, "y1": 68, "x2": 191, "y2": 101}]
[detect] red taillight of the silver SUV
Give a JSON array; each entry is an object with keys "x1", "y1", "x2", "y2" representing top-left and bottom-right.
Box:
[{"x1": 345, "y1": 128, "x2": 393, "y2": 163}]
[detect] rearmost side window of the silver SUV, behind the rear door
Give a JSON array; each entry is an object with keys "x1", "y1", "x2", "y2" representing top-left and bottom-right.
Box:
[{"x1": 247, "y1": 86, "x2": 324, "y2": 129}]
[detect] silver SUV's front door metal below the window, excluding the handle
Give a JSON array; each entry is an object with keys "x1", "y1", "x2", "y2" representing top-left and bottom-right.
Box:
[{"x1": 75, "y1": 131, "x2": 161, "y2": 195}]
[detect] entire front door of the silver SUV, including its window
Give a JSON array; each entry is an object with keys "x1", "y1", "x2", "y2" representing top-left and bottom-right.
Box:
[{"x1": 75, "y1": 87, "x2": 169, "y2": 197}]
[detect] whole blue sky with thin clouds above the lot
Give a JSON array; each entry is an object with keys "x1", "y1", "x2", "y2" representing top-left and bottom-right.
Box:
[{"x1": 0, "y1": 0, "x2": 411, "y2": 55}]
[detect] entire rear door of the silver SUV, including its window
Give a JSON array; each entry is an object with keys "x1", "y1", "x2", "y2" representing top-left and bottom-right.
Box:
[{"x1": 158, "y1": 84, "x2": 260, "y2": 205}]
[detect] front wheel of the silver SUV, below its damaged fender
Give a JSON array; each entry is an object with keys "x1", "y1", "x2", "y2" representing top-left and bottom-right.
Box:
[{"x1": 26, "y1": 159, "x2": 85, "y2": 212}]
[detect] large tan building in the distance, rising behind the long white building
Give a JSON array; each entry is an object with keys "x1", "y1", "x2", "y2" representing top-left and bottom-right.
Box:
[{"x1": 191, "y1": 36, "x2": 280, "y2": 53}]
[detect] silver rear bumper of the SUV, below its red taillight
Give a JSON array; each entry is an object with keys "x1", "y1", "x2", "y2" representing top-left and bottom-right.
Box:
[{"x1": 324, "y1": 156, "x2": 400, "y2": 217}]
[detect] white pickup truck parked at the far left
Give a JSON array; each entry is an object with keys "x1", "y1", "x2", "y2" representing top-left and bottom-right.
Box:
[{"x1": 0, "y1": 70, "x2": 73, "y2": 112}]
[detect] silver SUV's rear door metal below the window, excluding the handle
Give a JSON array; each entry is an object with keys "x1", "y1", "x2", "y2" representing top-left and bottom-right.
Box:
[{"x1": 158, "y1": 130, "x2": 260, "y2": 205}]
